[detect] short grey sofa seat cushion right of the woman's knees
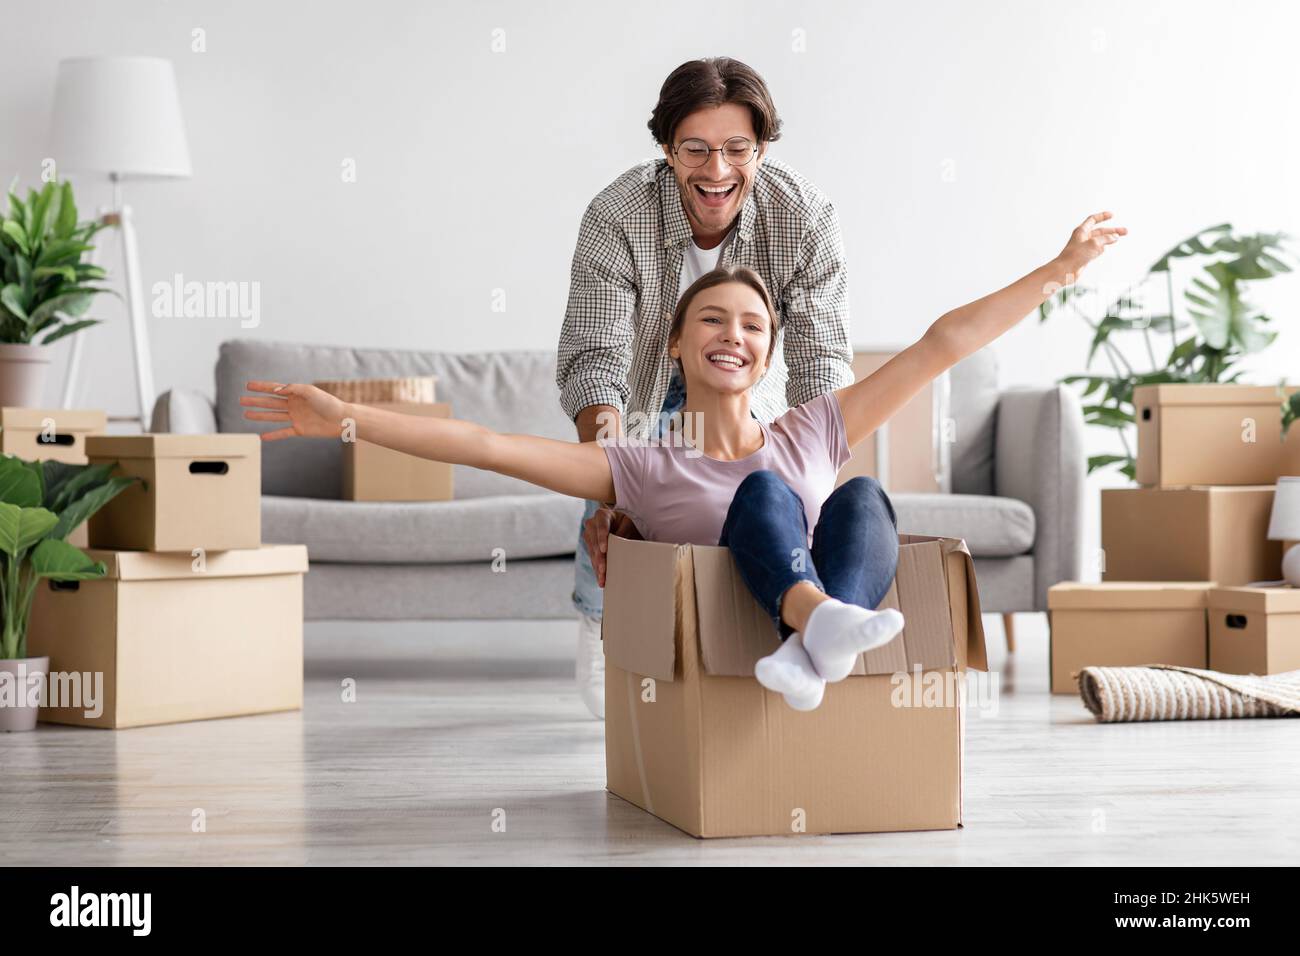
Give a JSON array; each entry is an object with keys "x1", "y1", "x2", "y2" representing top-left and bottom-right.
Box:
[{"x1": 889, "y1": 493, "x2": 1034, "y2": 558}]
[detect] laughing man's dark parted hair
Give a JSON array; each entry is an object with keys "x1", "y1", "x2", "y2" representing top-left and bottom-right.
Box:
[{"x1": 646, "y1": 56, "x2": 781, "y2": 146}]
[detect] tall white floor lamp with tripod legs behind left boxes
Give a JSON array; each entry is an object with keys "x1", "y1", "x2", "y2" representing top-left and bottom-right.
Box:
[{"x1": 51, "y1": 56, "x2": 190, "y2": 432}]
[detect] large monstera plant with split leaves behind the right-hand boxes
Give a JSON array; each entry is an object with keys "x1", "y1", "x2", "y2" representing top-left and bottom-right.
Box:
[{"x1": 1039, "y1": 222, "x2": 1300, "y2": 480}]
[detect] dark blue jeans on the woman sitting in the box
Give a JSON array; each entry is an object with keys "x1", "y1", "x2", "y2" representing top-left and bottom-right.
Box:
[{"x1": 718, "y1": 471, "x2": 898, "y2": 640}]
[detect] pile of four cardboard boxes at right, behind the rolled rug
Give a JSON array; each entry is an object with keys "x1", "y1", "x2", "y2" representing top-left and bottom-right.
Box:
[{"x1": 1048, "y1": 385, "x2": 1300, "y2": 693}]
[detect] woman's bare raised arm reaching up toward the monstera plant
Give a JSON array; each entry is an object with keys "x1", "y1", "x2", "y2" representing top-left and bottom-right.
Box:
[{"x1": 835, "y1": 212, "x2": 1128, "y2": 447}]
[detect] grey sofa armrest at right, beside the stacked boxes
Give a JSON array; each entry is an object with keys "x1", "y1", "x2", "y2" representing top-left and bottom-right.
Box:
[{"x1": 993, "y1": 385, "x2": 1087, "y2": 610}]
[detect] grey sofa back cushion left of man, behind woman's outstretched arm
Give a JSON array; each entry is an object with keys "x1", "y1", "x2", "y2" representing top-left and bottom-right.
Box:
[{"x1": 216, "y1": 339, "x2": 577, "y2": 498}]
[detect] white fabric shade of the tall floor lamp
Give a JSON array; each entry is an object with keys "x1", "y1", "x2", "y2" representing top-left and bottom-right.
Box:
[{"x1": 51, "y1": 56, "x2": 190, "y2": 179}]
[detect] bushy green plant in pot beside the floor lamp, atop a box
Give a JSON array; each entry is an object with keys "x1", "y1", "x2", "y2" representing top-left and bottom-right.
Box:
[{"x1": 0, "y1": 182, "x2": 109, "y2": 407}]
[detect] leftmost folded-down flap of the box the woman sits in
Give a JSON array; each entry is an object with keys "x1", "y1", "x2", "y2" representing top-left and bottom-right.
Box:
[{"x1": 601, "y1": 535, "x2": 689, "y2": 680}]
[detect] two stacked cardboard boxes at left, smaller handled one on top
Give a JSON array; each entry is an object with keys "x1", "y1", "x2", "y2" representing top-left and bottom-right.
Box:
[{"x1": 27, "y1": 434, "x2": 307, "y2": 727}]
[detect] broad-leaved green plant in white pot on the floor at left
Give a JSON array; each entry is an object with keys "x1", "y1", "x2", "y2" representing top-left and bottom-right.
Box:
[{"x1": 0, "y1": 455, "x2": 137, "y2": 731}]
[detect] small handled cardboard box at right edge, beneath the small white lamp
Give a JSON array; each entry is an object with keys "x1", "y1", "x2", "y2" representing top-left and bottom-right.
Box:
[{"x1": 1209, "y1": 587, "x2": 1300, "y2": 674}]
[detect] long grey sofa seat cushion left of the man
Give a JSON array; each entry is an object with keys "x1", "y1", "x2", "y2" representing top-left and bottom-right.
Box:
[{"x1": 261, "y1": 492, "x2": 582, "y2": 564}]
